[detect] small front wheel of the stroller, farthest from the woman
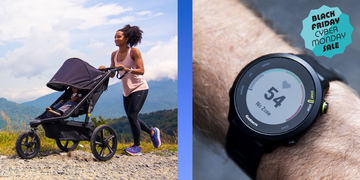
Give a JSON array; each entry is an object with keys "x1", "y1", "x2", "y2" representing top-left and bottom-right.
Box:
[{"x1": 15, "y1": 130, "x2": 40, "y2": 159}]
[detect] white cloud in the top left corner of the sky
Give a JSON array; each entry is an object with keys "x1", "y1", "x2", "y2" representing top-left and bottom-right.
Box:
[{"x1": 0, "y1": 0, "x2": 133, "y2": 41}]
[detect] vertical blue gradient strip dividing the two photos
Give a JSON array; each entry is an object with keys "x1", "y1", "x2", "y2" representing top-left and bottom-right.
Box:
[{"x1": 178, "y1": 0, "x2": 192, "y2": 180}]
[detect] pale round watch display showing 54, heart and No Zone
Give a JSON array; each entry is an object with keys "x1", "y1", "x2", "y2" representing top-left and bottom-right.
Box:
[{"x1": 246, "y1": 69, "x2": 305, "y2": 125}]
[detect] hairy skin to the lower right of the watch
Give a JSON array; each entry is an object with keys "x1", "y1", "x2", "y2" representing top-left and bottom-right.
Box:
[{"x1": 257, "y1": 81, "x2": 360, "y2": 179}]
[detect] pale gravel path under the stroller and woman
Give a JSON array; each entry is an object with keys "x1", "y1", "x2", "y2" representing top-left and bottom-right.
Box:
[{"x1": 0, "y1": 150, "x2": 178, "y2": 180}]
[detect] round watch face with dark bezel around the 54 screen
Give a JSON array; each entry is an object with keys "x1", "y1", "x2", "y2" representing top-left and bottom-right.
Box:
[{"x1": 234, "y1": 57, "x2": 316, "y2": 134}]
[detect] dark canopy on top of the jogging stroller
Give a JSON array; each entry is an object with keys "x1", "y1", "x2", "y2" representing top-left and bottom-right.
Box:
[{"x1": 46, "y1": 58, "x2": 106, "y2": 91}]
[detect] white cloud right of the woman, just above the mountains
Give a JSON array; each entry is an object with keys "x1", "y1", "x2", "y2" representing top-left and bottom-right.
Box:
[{"x1": 143, "y1": 36, "x2": 178, "y2": 81}]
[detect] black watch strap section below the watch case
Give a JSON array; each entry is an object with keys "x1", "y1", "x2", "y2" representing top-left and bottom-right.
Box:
[{"x1": 226, "y1": 120, "x2": 264, "y2": 179}]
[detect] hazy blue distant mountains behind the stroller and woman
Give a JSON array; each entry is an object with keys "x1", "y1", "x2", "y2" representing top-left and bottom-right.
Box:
[{"x1": 0, "y1": 80, "x2": 178, "y2": 127}]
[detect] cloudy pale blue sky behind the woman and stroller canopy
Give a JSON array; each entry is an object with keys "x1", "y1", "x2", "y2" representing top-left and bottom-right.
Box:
[{"x1": 0, "y1": 0, "x2": 178, "y2": 103}]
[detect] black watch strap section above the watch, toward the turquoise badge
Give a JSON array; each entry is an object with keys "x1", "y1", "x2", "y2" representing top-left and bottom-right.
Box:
[{"x1": 296, "y1": 54, "x2": 347, "y2": 84}]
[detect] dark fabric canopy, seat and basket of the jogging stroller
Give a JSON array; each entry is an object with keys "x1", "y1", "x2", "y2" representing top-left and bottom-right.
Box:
[{"x1": 36, "y1": 58, "x2": 109, "y2": 141}]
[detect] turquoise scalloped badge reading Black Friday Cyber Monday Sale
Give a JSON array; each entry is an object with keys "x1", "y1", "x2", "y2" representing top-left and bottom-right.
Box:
[{"x1": 301, "y1": 5, "x2": 354, "y2": 58}]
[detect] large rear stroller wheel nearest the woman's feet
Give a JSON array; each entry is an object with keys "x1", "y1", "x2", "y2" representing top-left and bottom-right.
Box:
[{"x1": 90, "y1": 125, "x2": 117, "y2": 161}]
